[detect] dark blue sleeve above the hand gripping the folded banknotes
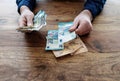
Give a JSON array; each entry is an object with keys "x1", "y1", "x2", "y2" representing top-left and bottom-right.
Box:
[{"x1": 16, "y1": 0, "x2": 36, "y2": 13}]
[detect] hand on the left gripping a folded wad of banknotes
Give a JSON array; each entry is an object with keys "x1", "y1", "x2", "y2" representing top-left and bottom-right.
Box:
[{"x1": 18, "y1": 6, "x2": 34, "y2": 27}]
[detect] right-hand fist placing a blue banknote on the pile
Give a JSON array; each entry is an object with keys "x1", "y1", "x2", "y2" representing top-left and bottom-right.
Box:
[{"x1": 69, "y1": 10, "x2": 92, "y2": 35}]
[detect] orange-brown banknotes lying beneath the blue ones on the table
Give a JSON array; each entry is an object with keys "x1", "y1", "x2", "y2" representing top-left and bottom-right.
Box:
[{"x1": 53, "y1": 37, "x2": 88, "y2": 58}]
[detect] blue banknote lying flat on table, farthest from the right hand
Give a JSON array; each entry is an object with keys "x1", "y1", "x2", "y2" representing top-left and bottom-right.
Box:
[{"x1": 45, "y1": 30, "x2": 64, "y2": 50}]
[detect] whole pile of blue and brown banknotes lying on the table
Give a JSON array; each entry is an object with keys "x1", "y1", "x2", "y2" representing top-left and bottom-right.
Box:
[{"x1": 45, "y1": 22, "x2": 88, "y2": 57}]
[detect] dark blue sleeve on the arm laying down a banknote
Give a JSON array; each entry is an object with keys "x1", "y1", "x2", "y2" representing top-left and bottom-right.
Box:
[{"x1": 84, "y1": 0, "x2": 106, "y2": 18}]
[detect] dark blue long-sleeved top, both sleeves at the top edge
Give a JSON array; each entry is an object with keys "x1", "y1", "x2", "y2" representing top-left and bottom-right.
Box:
[{"x1": 16, "y1": 0, "x2": 106, "y2": 18}]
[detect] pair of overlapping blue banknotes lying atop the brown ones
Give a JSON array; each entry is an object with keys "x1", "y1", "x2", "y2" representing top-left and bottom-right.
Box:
[{"x1": 46, "y1": 22, "x2": 76, "y2": 50}]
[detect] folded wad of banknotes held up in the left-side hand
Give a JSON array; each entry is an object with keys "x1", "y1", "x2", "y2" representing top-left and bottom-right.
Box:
[{"x1": 17, "y1": 10, "x2": 47, "y2": 32}]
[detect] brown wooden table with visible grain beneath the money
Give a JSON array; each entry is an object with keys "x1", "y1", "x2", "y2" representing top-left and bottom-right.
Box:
[{"x1": 0, "y1": 0, "x2": 120, "y2": 81}]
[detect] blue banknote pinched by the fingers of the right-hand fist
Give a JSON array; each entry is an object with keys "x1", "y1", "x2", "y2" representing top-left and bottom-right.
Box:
[{"x1": 58, "y1": 22, "x2": 76, "y2": 43}]
